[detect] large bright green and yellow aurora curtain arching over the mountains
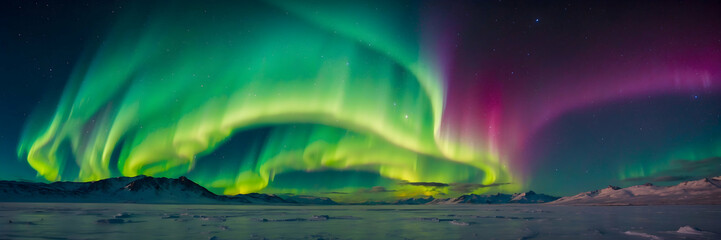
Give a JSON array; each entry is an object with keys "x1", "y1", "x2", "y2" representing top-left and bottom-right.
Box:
[{"x1": 18, "y1": 1, "x2": 522, "y2": 200}]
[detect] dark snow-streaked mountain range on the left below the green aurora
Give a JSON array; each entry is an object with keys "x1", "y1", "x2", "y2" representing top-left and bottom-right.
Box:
[{"x1": 0, "y1": 176, "x2": 336, "y2": 204}]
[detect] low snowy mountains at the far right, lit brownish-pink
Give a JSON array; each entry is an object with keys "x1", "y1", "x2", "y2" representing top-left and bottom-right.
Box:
[{"x1": 550, "y1": 176, "x2": 721, "y2": 205}]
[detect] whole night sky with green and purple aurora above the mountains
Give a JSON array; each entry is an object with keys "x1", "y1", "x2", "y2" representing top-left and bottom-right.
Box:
[{"x1": 0, "y1": 0, "x2": 721, "y2": 202}]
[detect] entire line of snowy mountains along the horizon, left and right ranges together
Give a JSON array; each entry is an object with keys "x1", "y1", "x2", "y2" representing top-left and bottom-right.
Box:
[{"x1": 0, "y1": 176, "x2": 721, "y2": 205}]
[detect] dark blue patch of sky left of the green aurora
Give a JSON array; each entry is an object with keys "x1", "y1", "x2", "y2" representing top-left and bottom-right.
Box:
[{"x1": 0, "y1": 1, "x2": 122, "y2": 179}]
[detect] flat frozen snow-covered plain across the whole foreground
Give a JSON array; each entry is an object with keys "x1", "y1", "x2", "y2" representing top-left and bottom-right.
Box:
[{"x1": 0, "y1": 203, "x2": 721, "y2": 239}]
